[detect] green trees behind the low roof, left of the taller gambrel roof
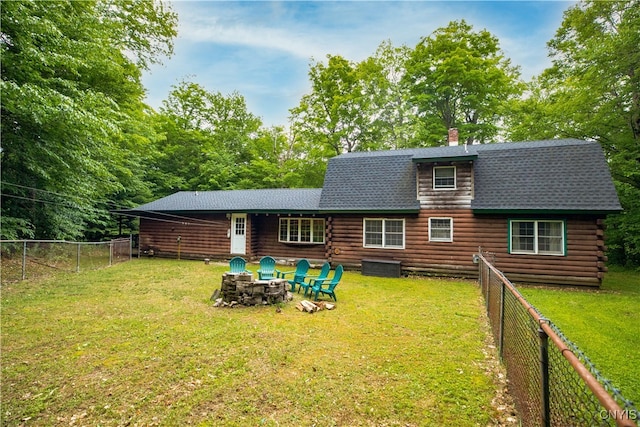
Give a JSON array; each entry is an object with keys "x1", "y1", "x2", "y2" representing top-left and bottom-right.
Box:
[{"x1": 150, "y1": 81, "x2": 324, "y2": 192}]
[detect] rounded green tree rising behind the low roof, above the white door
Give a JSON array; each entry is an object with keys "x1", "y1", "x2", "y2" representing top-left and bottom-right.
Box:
[{"x1": 152, "y1": 81, "x2": 261, "y2": 196}]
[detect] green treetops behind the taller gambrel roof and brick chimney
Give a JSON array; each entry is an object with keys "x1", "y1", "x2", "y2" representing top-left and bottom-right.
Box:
[{"x1": 291, "y1": 21, "x2": 522, "y2": 161}]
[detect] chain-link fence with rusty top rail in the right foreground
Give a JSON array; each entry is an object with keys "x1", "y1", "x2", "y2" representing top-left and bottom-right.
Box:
[{"x1": 478, "y1": 253, "x2": 640, "y2": 427}]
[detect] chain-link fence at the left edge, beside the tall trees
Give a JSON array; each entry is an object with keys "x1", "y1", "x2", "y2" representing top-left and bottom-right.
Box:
[{"x1": 0, "y1": 237, "x2": 132, "y2": 283}]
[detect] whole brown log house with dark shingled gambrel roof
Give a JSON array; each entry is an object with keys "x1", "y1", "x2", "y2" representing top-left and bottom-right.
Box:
[{"x1": 127, "y1": 139, "x2": 621, "y2": 286}]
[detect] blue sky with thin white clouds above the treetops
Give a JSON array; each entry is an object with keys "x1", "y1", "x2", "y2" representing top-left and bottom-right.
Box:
[{"x1": 143, "y1": 1, "x2": 575, "y2": 126}]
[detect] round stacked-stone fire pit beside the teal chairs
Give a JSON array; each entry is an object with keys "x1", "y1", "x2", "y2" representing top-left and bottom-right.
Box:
[{"x1": 220, "y1": 273, "x2": 289, "y2": 305}]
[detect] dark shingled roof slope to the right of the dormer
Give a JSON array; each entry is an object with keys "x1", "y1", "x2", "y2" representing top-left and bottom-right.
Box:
[{"x1": 471, "y1": 140, "x2": 621, "y2": 211}]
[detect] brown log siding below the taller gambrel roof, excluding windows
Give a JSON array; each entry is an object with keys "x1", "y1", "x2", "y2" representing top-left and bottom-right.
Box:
[{"x1": 328, "y1": 209, "x2": 605, "y2": 285}]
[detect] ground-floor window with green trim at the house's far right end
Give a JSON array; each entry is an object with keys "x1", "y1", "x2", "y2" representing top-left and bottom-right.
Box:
[{"x1": 509, "y1": 220, "x2": 565, "y2": 255}]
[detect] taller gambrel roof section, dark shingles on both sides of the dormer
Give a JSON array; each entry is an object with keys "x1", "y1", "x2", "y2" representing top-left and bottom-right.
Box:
[{"x1": 320, "y1": 139, "x2": 621, "y2": 212}]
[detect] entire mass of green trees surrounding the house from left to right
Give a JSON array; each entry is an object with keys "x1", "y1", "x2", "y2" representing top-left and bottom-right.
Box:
[{"x1": 0, "y1": 0, "x2": 640, "y2": 256}]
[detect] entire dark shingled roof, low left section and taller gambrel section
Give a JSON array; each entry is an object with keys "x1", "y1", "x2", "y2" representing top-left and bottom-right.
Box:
[{"x1": 127, "y1": 139, "x2": 621, "y2": 213}]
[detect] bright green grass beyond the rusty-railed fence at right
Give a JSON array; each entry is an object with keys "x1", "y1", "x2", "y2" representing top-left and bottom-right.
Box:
[{"x1": 519, "y1": 268, "x2": 640, "y2": 407}]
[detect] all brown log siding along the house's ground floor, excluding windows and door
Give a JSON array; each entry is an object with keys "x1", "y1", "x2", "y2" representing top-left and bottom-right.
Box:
[{"x1": 140, "y1": 209, "x2": 606, "y2": 286}]
